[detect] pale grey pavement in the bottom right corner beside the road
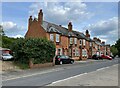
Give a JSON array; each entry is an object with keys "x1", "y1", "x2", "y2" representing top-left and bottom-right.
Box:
[{"x1": 47, "y1": 65, "x2": 118, "y2": 86}]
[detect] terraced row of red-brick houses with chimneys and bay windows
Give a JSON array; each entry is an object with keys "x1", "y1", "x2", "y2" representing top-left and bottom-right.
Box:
[{"x1": 25, "y1": 10, "x2": 110, "y2": 60}]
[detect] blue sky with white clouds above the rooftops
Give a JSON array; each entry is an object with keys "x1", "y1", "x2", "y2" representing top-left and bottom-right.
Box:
[{"x1": 0, "y1": 2, "x2": 118, "y2": 44}]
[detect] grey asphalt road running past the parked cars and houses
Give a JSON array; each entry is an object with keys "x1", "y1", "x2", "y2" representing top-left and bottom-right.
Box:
[{"x1": 2, "y1": 58, "x2": 119, "y2": 86}]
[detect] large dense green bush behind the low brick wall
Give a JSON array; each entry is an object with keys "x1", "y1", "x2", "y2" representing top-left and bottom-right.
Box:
[{"x1": 11, "y1": 38, "x2": 55, "y2": 68}]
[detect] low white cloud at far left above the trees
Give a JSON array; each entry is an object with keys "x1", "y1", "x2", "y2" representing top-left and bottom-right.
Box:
[{"x1": 1, "y1": 21, "x2": 26, "y2": 38}]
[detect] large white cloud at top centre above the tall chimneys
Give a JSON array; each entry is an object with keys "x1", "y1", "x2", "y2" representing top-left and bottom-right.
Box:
[{"x1": 29, "y1": 2, "x2": 93, "y2": 25}]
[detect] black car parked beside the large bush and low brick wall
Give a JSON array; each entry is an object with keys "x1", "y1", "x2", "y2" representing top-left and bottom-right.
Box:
[{"x1": 55, "y1": 55, "x2": 74, "y2": 65}]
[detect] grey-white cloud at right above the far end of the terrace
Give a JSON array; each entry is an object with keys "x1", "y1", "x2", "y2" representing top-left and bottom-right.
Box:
[{"x1": 87, "y1": 17, "x2": 118, "y2": 44}]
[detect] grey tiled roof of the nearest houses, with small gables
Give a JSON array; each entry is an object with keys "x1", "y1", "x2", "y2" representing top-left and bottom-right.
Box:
[{"x1": 42, "y1": 21, "x2": 92, "y2": 41}]
